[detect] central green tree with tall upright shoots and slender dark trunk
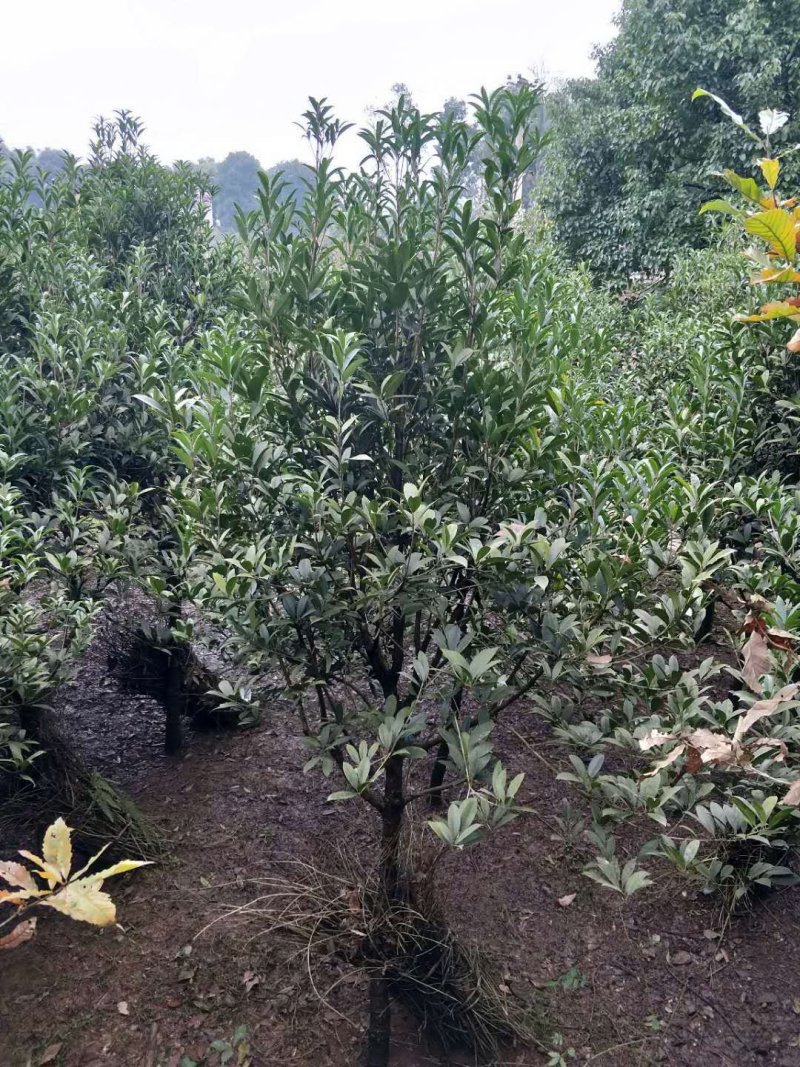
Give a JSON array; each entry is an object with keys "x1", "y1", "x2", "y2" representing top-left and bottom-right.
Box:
[{"x1": 164, "y1": 86, "x2": 721, "y2": 1067}]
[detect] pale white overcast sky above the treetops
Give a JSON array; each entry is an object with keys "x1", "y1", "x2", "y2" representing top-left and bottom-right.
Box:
[{"x1": 0, "y1": 0, "x2": 619, "y2": 166}]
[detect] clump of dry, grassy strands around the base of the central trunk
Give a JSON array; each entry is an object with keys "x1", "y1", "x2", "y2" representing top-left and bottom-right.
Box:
[{"x1": 198, "y1": 857, "x2": 541, "y2": 1063}]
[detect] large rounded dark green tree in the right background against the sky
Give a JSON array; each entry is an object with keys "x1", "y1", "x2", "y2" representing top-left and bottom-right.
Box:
[{"x1": 542, "y1": 0, "x2": 800, "y2": 278}]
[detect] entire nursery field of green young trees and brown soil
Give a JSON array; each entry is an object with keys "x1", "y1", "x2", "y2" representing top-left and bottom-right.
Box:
[{"x1": 0, "y1": 68, "x2": 800, "y2": 1067}]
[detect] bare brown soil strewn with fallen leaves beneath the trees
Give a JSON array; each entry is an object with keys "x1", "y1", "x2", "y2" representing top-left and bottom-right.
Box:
[{"x1": 0, "y1": 618, "x2": 800, "y2": 1067}]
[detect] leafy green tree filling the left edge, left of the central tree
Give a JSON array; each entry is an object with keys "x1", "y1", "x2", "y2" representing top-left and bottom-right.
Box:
[{"x1": 0, "y1": 113, "x2": 236, "y2": 813}]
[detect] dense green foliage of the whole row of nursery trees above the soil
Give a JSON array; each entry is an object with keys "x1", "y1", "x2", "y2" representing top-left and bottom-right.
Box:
[{"x1": 0, "y1": 73, "x2": 800, "y2": 1067}]
